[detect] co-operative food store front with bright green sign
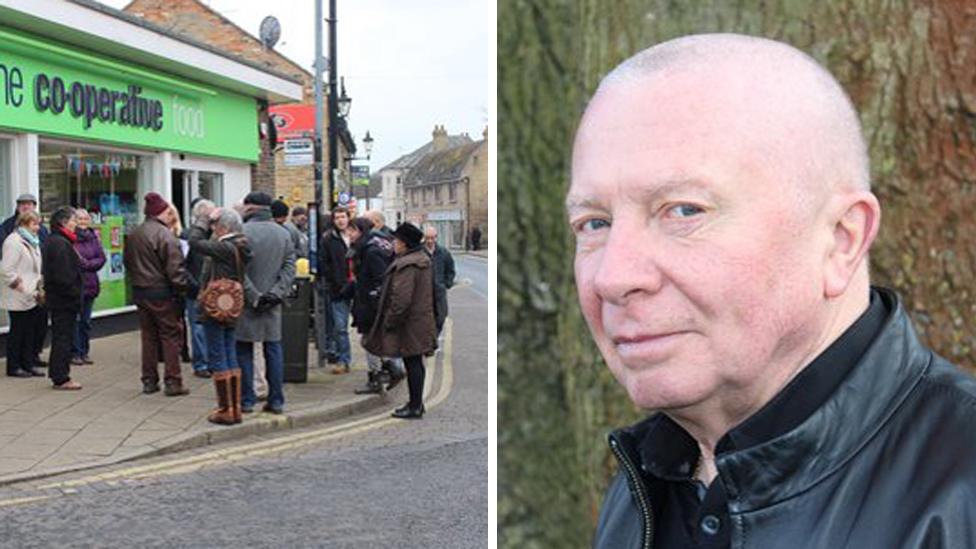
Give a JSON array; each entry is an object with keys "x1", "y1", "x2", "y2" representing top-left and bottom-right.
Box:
[{"x1": 0, "y1": 2, "x2": 301, "y2": 325}]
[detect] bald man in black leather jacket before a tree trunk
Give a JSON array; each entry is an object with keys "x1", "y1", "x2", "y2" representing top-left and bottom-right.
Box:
[{"x1": 566, "y1": 35, "x2": 976, "y2": 549}]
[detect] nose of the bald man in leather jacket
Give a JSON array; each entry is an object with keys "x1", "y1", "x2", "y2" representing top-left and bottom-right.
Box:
[{"x1": 594, "y1": 226, "x2": 663, "y2": 305}]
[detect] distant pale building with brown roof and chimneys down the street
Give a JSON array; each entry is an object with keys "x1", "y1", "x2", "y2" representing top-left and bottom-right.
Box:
[{"x1": 402, "y1": 127, "x2": 490, "y2": 249}]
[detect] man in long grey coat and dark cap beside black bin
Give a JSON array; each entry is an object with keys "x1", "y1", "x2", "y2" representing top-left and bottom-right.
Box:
[{"x1": 235, "y1": 192, "x2": 295, "y2": 414}]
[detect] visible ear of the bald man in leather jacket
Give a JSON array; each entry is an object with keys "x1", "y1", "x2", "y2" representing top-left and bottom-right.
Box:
[{"x1": 824, "y1": 191, "x2": 881, "y2": 298}]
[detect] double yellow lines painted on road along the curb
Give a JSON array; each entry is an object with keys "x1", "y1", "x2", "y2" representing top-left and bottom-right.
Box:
[{"x1": 30, "y1": 318, "x2": 454, "y2": 492}]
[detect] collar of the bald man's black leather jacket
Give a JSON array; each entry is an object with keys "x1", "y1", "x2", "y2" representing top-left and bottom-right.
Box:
[{"x1": 610, "y1": 288, "x2": 933, "y2": 513}]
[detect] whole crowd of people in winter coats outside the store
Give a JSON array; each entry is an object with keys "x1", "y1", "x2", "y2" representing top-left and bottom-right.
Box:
[{"x1": 0, "y1": 191, "x2": 455, "y2": 425}]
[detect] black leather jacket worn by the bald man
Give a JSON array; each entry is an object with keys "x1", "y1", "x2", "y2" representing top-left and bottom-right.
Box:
[{"x1": 594, "y1": 290, "x2": 976, "y2": 549}]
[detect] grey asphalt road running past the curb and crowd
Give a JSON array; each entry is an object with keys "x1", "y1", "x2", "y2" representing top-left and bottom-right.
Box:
[{"x1": 0, "y1": 278, "x2": 494, "y2": 548}]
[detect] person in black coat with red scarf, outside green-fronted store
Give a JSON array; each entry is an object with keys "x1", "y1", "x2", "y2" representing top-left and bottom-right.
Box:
[{"x1": 41, "y1": 206, "x2": 82, "y2": 391}]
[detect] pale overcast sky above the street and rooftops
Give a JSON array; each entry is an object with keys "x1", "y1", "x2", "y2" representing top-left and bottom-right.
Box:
[{"x1": 101, "y1": 0, "x2": 495, "y2": 170}]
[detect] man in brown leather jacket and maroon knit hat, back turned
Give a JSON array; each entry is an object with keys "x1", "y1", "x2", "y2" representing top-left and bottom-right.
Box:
[{"x1": 123, "y1": 193, "x2": 190, "y2": 396}]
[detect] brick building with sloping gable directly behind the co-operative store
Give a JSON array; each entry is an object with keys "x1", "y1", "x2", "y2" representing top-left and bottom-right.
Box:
[{"x1": 123, "y1": 0, "x2": 355, "y2": 209}]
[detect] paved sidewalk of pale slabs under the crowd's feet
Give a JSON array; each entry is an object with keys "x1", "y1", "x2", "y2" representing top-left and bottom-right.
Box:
[{"x1": 0, "y1": 331, "x2": 390, "y2": 485}]
